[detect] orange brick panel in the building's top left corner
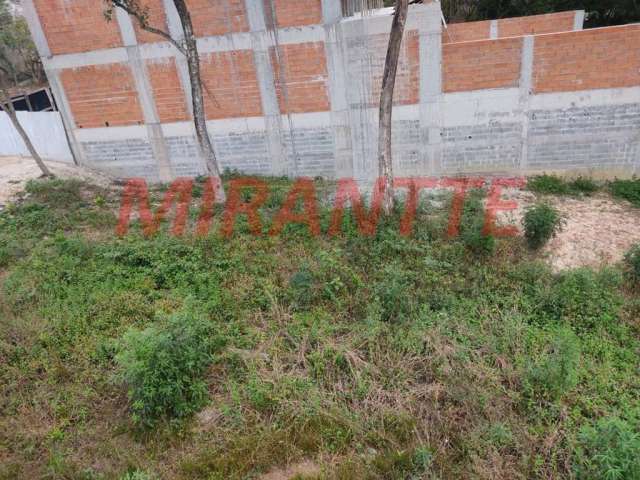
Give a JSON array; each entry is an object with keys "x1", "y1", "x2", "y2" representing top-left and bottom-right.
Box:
[{"x1": 34, "y1": 0, "x2": 122, "y2": 54}]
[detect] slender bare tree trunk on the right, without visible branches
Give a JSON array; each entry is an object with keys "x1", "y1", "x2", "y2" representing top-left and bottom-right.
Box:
[{"x1": 378, "y1": 0, "x2": 409, "y2": 215}]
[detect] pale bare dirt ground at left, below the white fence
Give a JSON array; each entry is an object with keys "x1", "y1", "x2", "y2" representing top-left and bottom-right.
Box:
[{"x1": 0, "y1": 157, "x2": 112, "y2": 208}]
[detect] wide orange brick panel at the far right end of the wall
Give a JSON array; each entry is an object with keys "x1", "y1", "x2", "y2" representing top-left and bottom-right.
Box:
[{"x1": 533, "y1": 25, "x2": 640, "y2": 93}]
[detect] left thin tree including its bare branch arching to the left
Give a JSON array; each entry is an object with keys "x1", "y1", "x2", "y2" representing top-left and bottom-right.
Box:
[{"x1": 105, "y1": 0, "x2": 224, "y2": 201}]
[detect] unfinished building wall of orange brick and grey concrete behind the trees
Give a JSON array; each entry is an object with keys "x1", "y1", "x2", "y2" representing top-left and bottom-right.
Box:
[{"x1": 24, "y1": 0, "x2": 640, "y2": 180}]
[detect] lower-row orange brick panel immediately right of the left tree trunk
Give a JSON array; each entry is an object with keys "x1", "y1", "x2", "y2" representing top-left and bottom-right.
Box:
[{"x1": 200, "y1": 50, "x2": 262, "y2": 119}]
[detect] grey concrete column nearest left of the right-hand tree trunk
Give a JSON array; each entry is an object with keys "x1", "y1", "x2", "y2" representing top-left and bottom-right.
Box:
[{"x1": 322, "y1": 0, "x2": 354, "y2": 178}]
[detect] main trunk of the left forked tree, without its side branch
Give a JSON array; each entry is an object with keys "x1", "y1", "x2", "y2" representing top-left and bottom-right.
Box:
[{"x1": 173, "y1": 0, "x2": 225, "y2": 202}]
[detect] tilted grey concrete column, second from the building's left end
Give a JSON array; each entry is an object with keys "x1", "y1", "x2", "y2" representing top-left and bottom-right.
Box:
[{"x1": 116, "y1": 8, "x2": 173, "y2": 182}]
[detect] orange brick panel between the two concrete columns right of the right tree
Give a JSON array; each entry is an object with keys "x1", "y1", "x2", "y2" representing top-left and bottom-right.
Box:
[{"x1": 442, "y1": 38, "x2": 522, "y2": 92}]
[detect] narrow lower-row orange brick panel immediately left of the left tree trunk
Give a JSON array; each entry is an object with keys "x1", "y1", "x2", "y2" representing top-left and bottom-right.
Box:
[{"x1": 147, "y1": 58, "x2": 189, "y2": 123}]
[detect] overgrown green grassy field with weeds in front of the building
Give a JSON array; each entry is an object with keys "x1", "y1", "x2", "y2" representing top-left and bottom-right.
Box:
[{"x1": 0, "y1": 179, "x2": 640, "y2": 480}]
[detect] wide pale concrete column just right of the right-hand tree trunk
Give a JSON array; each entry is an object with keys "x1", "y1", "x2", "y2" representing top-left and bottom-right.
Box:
[{"x1": 418, "y1": 2, "x2": 443, "y2": 174}]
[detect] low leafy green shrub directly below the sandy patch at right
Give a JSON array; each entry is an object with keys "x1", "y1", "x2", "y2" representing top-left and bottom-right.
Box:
[{"x1": 541, "y1": 268, "x2": 623, "y2": 331}]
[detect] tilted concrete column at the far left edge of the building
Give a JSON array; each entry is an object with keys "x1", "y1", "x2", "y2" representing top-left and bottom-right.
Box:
[{"x1": 22, "y1": 0, "x2": 85, "y2": 165}]
